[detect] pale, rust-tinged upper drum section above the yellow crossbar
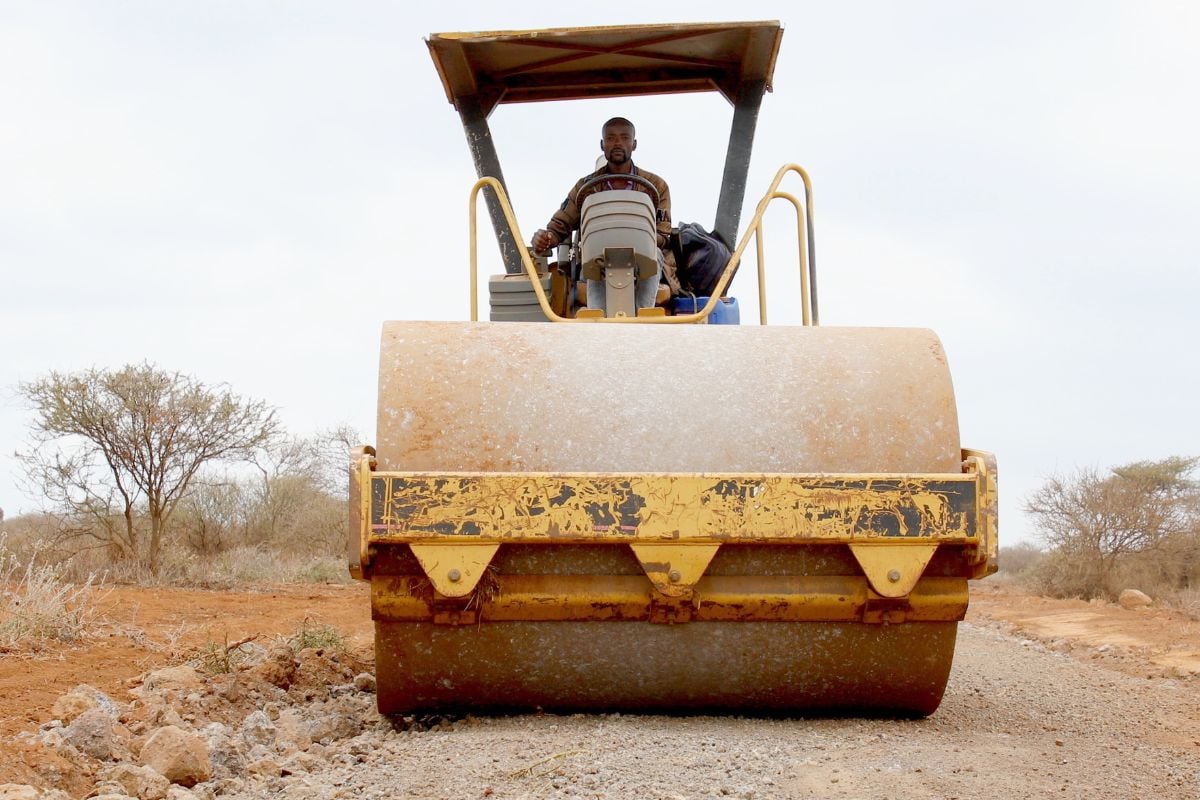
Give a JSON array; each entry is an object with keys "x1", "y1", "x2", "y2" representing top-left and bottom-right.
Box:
[{"x1": 376, "y1": 321, "x2": 960, "y2": 473}]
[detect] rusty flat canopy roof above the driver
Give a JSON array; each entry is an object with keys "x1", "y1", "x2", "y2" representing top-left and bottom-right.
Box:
[{"x1": 426, "y1": 22, "x2": 784, "y2": 115}]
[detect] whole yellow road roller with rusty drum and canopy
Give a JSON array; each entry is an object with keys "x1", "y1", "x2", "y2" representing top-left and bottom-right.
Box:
[{"x1": 347, "y1": 22, "x2": 997, "y2": 717}]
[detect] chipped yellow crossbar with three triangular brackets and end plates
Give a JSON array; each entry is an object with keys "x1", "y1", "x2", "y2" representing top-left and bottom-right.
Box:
[{"x1": 350, "y1": 451, "x2": 996, "y2": 597}]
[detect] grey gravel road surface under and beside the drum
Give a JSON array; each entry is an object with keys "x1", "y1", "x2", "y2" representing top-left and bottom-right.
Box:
[{"x1": 221, "y1": 620, "x2": 1200, "y2": 800}]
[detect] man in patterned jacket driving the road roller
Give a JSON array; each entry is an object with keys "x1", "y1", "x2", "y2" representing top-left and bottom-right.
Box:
[{"x1": 529, "y1": 116, "x2": 671, "y2": 308}]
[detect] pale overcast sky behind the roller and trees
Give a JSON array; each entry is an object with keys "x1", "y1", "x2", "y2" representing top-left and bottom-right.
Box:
[{"x1": 0, "y1": 0, "x2": 1200, "y2": 542}]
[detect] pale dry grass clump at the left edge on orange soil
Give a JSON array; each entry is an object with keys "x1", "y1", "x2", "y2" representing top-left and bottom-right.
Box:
[{"x1": 0, "y1": 534, "x2": 96, "y2": 650}]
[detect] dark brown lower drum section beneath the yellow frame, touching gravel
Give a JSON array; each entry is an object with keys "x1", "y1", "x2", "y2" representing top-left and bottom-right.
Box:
[{"x1": 376, "y1": 622, "x2": 955, "y2": 716}]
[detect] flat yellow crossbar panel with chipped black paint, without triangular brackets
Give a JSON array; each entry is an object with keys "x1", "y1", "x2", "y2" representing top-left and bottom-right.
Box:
[{"x1": 370, "y1": 473, "x2": 978, "y2": 543}]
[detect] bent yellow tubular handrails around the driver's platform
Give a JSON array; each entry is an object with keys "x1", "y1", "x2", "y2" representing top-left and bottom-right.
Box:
[{"x1": 469, "y1": 164, "x2": 815, "y2": 325}]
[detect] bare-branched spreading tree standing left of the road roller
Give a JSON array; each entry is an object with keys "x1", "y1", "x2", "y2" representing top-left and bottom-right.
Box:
[{"x1": 17, "y1": 363, "x2": 282, "y2": 573}]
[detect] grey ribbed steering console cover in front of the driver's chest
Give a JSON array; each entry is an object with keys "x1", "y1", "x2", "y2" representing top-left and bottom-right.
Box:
[{"x1": 580, "y1": 190, "x2": 659, "y2": 280}]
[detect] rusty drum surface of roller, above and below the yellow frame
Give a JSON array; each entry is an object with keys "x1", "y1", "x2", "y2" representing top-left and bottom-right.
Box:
[{"x1": 373, "y1": 323, "x2": 961, "y2": 715}]
